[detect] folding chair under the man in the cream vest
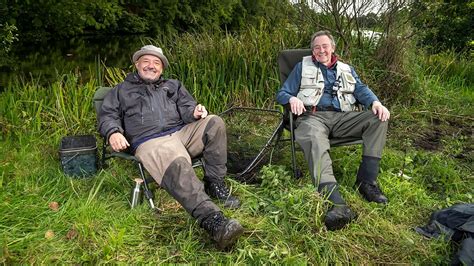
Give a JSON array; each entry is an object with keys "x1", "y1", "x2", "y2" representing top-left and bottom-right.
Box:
[{"x1": 276, "y1": 49, "x2": 362, "y2": 178}]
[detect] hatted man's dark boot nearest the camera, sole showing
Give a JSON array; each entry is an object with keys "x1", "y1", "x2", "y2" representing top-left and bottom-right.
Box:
[{"x1": 201, "y1": 212, "x2": 244, "y2": 250}]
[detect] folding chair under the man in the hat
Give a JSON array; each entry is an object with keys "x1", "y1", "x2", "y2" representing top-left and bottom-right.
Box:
[{"x1": 94, "y1": 87, "x2": 203, "y2": 210}]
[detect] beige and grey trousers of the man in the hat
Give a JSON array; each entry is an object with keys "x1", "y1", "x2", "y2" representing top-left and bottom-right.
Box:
[{"x1": 135, "y1": 115, "x2": 227, "y2": 222}]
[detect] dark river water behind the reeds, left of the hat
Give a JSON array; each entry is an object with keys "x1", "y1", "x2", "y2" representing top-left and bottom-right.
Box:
[{"x1": 0, "y1": 35, "x2": 150, "y2": 91}]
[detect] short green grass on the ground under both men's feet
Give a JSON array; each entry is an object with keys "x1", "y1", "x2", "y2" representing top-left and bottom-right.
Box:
[{"x1": 0, "y1": 139, "x2": 466, "y2": 264}]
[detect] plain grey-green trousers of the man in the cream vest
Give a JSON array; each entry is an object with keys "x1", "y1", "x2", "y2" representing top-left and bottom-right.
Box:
[{"x1": 295, "y1": 111, "x2": 388, "y2": 187}]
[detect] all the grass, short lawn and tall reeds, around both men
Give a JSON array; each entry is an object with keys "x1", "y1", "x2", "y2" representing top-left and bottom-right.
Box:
[{"x1": 0, "y1": 31, "x2": 474, "y2": 264}]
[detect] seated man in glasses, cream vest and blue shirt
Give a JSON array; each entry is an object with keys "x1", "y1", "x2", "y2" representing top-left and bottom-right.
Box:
[{"x1": 276, "y1": 31, "x2": 390, "y2": 230}]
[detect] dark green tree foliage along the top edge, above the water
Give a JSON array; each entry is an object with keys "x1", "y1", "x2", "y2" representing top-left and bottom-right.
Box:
[{"x1": 0, "y1": 0, "x2": 291, "y2": 41}]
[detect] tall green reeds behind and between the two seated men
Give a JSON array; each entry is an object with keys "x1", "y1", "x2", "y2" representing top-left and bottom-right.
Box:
[{"x1": 108, "y1": 28, "x2": 310, "y2": 113}]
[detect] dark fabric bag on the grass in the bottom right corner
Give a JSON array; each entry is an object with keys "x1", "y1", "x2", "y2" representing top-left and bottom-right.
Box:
[{"x1": 415, "y1": 203, "x2": 474, "y2": 265}]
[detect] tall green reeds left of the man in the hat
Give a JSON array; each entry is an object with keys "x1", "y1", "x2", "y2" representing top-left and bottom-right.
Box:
[{"x1": 0, "y1": 73, "x2": 97, "y2": 140}]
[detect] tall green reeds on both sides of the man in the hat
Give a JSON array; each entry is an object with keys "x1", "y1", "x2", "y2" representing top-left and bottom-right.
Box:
[{"x1": 0, "y1": 28, "x2": 309, "y2": 140}]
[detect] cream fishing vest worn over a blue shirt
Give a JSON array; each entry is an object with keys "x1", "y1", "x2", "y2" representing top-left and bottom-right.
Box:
[{"x1": 296, "y1": 56, "x2": 357, "y2": 112}]
